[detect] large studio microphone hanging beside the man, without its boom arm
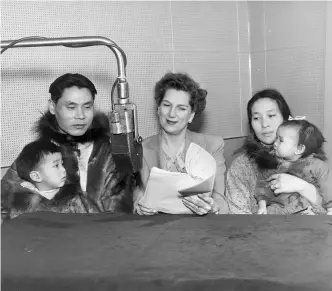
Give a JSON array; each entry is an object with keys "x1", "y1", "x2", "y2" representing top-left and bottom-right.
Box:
[{"x1": 109, "y1": 78, "x2": 143, "y2": 173}]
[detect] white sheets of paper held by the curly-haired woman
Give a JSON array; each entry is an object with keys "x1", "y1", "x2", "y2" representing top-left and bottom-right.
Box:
[{"x1": 141, "y1": 143, "x2": 216, "y2": 214}]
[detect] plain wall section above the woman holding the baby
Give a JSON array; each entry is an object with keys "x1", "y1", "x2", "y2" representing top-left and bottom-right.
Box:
[{"x1": 248, "y1": 1, "x2": 327, "y2": 130}]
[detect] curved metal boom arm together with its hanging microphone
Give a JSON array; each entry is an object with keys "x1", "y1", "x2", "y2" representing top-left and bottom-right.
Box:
[{"x1": 1, "y1": 36, "x2": 142, "y2": 172}]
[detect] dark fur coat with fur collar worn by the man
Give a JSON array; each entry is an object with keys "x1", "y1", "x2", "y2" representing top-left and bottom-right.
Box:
[{"x1": 1, "y1": 112, "x2": 135, "y2": 220}]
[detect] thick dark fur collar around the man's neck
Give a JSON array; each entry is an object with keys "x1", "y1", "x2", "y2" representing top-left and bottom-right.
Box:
[{"x1": 34, "y1": 111, "x2": 110, "y2": 144}]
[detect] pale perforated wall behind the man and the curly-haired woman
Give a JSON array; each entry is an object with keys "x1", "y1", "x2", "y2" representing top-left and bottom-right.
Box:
[{"x1": 0, "y1": 1, "x2": 250, "y2": 166}]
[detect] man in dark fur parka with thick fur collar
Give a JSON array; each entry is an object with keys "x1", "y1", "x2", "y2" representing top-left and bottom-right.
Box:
[{"x1": 1, "y1": 73, "x2": 134, "y2": 218}]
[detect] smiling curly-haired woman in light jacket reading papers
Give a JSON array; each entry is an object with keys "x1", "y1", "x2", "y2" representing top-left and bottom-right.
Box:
[{"x1": 134, "y1": 73, "x2": 228, "y2": 215}]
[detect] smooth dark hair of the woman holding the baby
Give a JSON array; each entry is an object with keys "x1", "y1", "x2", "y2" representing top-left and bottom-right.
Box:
[{"x1": 247, "y1": 88, "x2": 292, "y2": 133}]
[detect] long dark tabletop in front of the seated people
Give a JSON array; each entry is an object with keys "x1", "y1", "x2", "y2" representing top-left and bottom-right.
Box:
[{"x1": 1, "y1": 212, "x2": 332, "y2": 291}]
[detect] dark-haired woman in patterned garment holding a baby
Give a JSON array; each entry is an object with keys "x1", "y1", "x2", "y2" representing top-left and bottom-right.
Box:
[{"x1": 226, "y1": 89, "x2": 329, "y2": 214}]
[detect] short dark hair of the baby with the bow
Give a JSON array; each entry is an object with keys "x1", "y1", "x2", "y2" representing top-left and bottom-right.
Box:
[{"x1": 280, "y1": 120, "x2": 326, "y2": 161}]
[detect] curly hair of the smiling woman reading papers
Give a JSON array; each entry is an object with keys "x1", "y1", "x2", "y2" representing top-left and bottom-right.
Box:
[{"x1": 154, "y1": 72, "x2": 207, "y2": 116}]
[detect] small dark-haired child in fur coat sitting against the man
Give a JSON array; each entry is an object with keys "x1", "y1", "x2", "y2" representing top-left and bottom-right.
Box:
[{"x1": 9, "y1": 140, "x2": 85, "y2": 218}]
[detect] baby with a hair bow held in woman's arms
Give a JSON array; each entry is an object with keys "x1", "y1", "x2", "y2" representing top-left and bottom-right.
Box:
[{"x1": 255, "y1": 119, "x2": 332, "y2": 215}]
